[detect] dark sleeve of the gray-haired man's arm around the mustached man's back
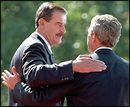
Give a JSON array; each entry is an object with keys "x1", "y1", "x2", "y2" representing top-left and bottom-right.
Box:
[{"x1": 13, "y1": 81, "x2": 73, "y2": 106}]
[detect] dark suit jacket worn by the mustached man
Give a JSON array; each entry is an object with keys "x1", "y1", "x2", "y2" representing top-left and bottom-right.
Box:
[{"x1": 8, "y1": 33, "x2": 73, "y2": 106}]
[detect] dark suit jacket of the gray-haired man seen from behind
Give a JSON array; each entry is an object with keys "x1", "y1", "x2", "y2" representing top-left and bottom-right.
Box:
[{"x1": 14, "y1": 49, "x2": 129, "y2": 106}]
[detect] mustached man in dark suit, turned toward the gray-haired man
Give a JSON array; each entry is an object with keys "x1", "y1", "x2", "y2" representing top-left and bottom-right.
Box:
[{"x1": 3, "y1": 3, "x2": 106, "y2": 106}]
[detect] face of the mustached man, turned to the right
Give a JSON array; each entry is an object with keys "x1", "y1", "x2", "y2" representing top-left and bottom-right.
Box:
[{"x1": 44, "y1": 11, "x2": 66, "y2": 45}]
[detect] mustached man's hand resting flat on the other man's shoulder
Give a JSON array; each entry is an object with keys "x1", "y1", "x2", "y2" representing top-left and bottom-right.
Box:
[{"x1": 73, "y1": 55, "x2": 107, "y2": 73}]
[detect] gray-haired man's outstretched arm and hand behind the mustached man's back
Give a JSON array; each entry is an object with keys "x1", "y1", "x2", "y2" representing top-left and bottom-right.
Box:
[{"x1": 2, "y1": 69, "x2": 73, "y2": 106}]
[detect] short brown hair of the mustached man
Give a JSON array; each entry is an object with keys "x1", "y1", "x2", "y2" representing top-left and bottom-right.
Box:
[{"x1": 35, "y1": 2, "x2": 67, "y2": 28}]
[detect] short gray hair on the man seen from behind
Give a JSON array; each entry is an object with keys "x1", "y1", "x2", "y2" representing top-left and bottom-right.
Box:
[{"x1": 89, "y1": 14, "x2": 122, "y2": 47}]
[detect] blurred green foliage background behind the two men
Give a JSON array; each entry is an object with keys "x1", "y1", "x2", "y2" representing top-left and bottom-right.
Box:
[{"x1": 1, "y1": 1, "x2": 129, "y2": 106}]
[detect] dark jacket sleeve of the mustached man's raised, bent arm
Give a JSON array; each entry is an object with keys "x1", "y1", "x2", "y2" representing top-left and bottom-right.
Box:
[{"x1": 22, "y1": 43, "x2": 73, "y2": 87}]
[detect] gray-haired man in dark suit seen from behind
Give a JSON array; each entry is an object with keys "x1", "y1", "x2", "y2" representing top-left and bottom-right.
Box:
[{"x1": 1, "y1": 14, "x2": 129, "y2": 106}]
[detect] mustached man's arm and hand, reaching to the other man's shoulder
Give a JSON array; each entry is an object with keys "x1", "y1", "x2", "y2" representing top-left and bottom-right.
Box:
[{"x1": 22, "y1": 43, "x2": 106, "y2": 87}]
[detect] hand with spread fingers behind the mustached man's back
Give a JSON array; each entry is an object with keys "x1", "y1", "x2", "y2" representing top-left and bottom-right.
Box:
[{"x1": 1, "y1": 67, "x2": 21, "y2": 90}]
